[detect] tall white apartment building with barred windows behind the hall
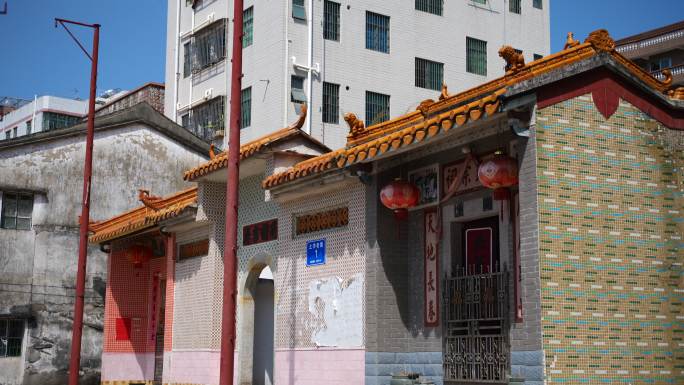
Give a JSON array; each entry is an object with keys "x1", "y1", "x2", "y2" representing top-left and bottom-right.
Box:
[{"x1": 164, "y1": 0, "x2": 550, "y2": 148}]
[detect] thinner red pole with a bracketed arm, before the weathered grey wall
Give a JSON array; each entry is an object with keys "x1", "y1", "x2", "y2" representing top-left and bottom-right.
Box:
[{"x1": 69, "y1": 23, "x2": 100, "y2": 385}]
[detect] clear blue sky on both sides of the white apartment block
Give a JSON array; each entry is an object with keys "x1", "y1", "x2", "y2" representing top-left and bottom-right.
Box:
[{"x1": 0, "y1": 0, "x2": 684, "y2": 99}]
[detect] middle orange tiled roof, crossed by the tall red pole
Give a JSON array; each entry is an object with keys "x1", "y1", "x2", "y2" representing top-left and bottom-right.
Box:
[{"x1": 183, "y1": 105, "x2": 314, "y2": 181}]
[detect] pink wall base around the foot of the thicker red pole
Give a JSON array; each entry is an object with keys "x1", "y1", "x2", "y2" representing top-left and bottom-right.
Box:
[{"x1": 163, "y1": 350, "x2": 238, "y2": 385}]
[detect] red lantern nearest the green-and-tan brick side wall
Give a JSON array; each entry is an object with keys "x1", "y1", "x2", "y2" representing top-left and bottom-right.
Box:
[{"x1": 477, "y1": 151, "x2": 518, "y2": 201}]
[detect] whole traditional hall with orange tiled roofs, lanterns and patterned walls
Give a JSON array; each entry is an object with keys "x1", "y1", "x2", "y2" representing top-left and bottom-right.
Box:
[{"x1": 91, "y1": 30, "x2": 684, "y2": 385}]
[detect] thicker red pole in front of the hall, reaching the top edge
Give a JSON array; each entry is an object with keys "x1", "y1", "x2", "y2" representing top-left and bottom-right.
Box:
[{"x1": 219, "y1": 0, "x2": 242, "y2": 385}]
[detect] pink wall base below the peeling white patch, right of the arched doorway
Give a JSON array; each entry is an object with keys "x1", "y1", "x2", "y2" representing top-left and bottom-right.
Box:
[{"x1": 275, "y1": 349, "x2": 365, "y2": 385}]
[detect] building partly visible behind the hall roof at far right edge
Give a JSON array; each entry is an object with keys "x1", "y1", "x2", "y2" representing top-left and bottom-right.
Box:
[{"x1": 615, "y1": 21, "x2": 684, "y2": 86}]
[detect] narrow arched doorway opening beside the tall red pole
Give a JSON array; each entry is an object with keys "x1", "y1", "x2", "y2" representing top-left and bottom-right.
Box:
[{"x1": 252, "y1": 266, "x2": 273, "y2": 385}]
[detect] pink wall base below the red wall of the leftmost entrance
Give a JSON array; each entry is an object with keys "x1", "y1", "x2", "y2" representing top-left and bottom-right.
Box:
[{"x1": 101, "y1": 352, "x2": 154, "y2": 381}]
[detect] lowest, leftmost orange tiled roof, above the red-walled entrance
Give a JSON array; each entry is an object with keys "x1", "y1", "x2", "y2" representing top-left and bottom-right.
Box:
[{"x1": 89, "y1": 187, "x2": 197, "y2": 243}]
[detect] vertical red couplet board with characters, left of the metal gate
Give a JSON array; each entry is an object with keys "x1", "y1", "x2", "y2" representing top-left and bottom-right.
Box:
[{"x1": 424, "y1": 209, "x2": 439, "y2": 327}]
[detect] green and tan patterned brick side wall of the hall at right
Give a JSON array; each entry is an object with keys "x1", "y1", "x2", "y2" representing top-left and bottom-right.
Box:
[{"x1": 537, "y1": 95, "x2": 684, "y2": 385}]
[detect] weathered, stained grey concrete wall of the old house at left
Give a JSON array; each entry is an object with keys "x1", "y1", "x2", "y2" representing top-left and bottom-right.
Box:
[{"x1": 0, "y1": 123, "x2": 204, "y2": 385}]
